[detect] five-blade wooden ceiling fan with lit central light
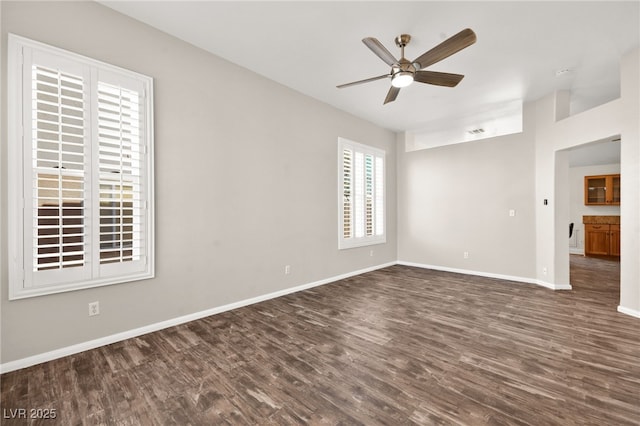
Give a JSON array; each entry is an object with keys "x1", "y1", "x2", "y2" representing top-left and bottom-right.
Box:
[{"x1": 336, "y1": 28, "x2": 476, "y2": 104}]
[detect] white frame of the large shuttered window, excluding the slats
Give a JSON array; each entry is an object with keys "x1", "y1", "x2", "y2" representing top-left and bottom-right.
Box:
[{"x1": 7, "y1": 34, "x2": 155, "y2": 300}]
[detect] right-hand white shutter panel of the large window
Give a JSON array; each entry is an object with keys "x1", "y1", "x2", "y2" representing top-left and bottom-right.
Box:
[{"x1": 95, "y1": 71, "x2": 148, "y2": 275}]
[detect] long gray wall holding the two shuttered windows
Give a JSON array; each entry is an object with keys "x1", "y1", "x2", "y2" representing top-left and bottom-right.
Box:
[{"x1": 0, "y1": 1, "x2": 397, "y2": 363}]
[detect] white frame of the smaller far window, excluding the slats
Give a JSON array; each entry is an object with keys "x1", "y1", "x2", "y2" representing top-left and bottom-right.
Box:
[{"x1": 338, "y1": 138, "x2": 387, "y2": 250}]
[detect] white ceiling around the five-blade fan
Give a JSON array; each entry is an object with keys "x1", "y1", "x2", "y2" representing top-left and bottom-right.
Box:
[{"x1": 100, "y1": 1, "x2": 640, "y2": 132}]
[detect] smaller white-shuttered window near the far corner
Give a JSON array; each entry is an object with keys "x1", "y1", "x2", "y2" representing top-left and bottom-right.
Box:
[{"x1": 338, "y1": 138, "x2": 386, "y2": 249}]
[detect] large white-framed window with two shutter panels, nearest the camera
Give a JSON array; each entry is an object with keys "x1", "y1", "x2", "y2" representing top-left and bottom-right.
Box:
[{"x1": 8, "y1": 35, "x2": 154, "y2": 299}]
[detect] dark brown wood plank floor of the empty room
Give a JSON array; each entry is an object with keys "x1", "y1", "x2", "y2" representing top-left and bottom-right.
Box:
[{"x1": 1, "y1": 256, "x2": 640, "y2": 425}]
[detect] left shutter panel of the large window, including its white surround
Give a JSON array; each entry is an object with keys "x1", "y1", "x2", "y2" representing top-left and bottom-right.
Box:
[{"x1": 24, "y1": 52, "x2": 89, "y2": 285}]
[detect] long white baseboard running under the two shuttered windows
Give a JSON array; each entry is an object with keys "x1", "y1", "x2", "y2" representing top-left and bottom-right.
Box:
[{"x1": 0, "y1": 262, "x2": 396, "y2": 374}]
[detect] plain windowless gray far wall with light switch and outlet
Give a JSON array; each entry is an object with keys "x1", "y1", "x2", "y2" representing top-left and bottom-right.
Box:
[{"x1": 398, "y1": 106, "x2": 535, "y2": 279}]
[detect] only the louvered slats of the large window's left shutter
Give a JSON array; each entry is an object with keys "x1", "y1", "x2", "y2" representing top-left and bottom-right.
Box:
[{"x1": 33, "y1": 66, "x2": 85, "y2": 270}]
